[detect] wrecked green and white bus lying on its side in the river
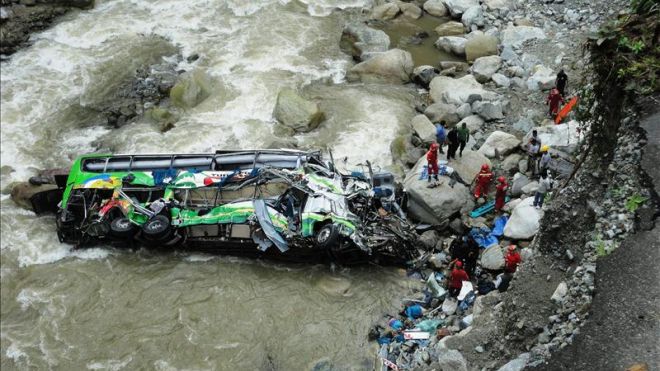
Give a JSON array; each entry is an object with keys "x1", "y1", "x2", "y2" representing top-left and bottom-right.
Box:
[{"x1": 32, "y1": 150, "x2": 425, "y2": 265}]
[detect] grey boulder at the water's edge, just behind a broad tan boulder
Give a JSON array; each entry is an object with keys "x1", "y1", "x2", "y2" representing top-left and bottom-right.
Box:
[{"x1": 339, "y1": 23, "x2": 390, "y2": 60}]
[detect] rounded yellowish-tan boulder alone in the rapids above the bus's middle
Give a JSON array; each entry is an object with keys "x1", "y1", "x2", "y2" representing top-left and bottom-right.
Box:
[{"x1": 273, "y1": 88, "x2": 325, "y2": 132}]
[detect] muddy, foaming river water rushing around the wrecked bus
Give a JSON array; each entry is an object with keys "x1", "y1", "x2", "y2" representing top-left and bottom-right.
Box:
[{"x1": 0, "y1": 0, "x2": 428, "y2": 370}]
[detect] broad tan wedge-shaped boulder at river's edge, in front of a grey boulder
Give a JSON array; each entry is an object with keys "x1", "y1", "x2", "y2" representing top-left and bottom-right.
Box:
[{"x1": 346, "y1": 49, "x2": 414, "y2": 84}]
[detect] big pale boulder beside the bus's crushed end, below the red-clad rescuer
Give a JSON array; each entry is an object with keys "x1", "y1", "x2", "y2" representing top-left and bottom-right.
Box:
[{"x1": 403, "y1": 156, "x2": 473, "y2": 224}]
